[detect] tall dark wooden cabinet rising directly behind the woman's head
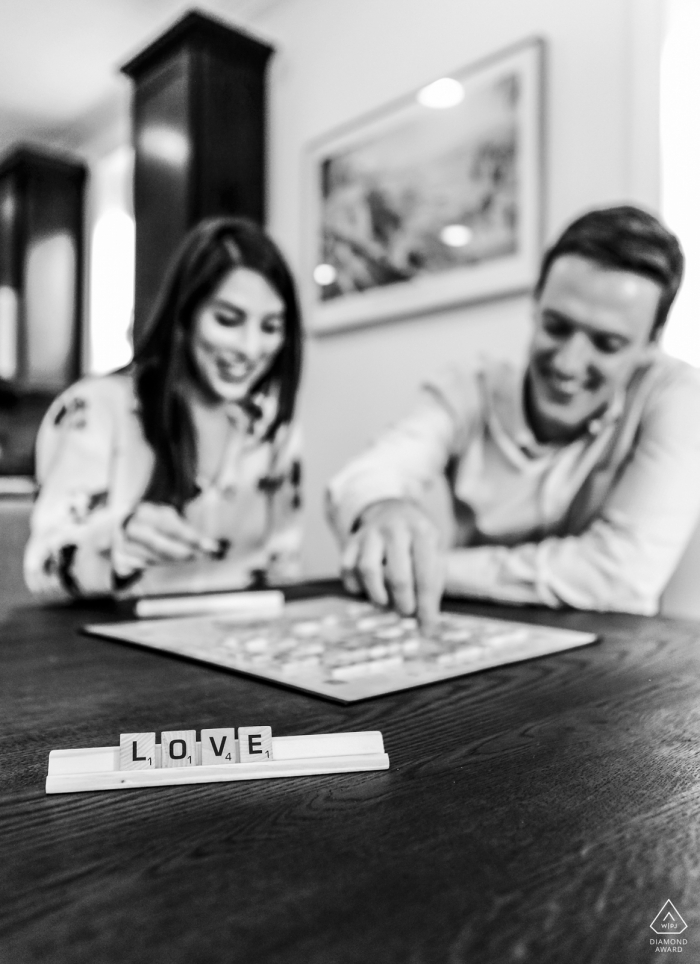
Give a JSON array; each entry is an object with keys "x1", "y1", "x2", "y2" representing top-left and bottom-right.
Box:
[{"x1": 122, "y1": 12, "x2": 272, "y2": 333}]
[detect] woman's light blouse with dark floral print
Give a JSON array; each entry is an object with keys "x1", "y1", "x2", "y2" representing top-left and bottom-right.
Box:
[{"x1": 24, "y1": 373, "x2": 301, "y2": 599}]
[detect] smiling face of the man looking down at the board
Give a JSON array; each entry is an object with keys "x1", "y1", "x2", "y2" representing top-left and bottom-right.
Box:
[{"x1": 528, "y1": 254, "x2": 661, "y2": 442}]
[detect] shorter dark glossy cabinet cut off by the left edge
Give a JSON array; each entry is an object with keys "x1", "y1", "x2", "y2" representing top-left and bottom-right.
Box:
[{"x1": 0, "y1": 147, "x2": 87, "y2": 475}]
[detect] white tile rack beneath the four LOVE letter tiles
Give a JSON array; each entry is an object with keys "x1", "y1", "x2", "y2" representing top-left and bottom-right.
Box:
[{"x1": 46, "y1": 730, "x2": 389, "y2": 793}]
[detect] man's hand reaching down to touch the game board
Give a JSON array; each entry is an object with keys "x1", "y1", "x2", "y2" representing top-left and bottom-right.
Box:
[{"x1": 342, "y1": 499, "x2": 445, "y2": 630}]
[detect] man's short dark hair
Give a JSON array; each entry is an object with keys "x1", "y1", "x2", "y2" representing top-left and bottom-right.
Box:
[{"x1": 535, "y1": 204, "x2": 684, "y2": 336}]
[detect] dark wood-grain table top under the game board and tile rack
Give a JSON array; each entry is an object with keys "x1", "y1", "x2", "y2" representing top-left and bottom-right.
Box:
[{"x1": 0, "y1": 586, "x2": 700, "y2": 964}]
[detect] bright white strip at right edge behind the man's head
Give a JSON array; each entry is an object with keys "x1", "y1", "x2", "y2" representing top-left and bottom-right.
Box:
[{"x1": 660, "y1": 0, "x2": 700, "y2": 365}]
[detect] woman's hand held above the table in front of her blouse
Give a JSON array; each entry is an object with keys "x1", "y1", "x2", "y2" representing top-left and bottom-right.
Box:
[{"x1": 113, "y1": 502, "x2": 219, "y2": 574}]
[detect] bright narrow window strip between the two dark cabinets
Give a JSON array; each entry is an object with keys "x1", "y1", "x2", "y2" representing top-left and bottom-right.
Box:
[{"x1": 87, "y1": 148, "x2": 135, "y2": 374}]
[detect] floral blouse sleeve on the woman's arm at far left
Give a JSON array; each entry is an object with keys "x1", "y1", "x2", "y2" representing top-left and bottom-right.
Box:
[{"x1": 24, "y1": 379, "x2": 119, "y2": 599}]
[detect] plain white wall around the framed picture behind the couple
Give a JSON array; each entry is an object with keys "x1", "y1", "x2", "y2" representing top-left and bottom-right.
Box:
[{"x1": 243, "y1": 0, "x2": 662, "y2": 574}]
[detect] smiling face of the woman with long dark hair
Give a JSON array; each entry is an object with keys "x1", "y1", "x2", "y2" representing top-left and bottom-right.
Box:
[{"x1": 190, "y1": 268, "x2": 285, "y2": 402}]
